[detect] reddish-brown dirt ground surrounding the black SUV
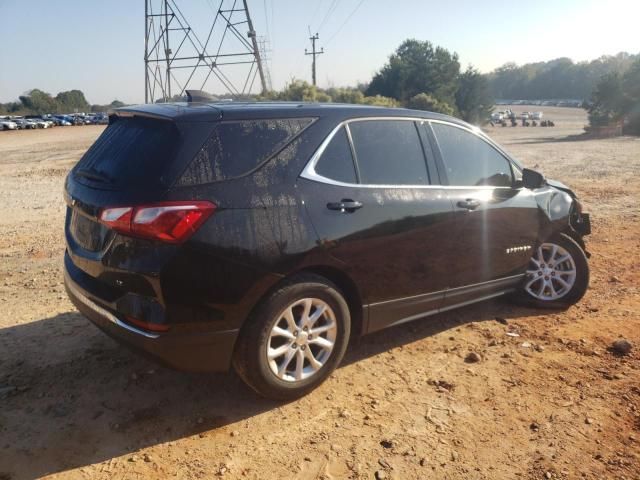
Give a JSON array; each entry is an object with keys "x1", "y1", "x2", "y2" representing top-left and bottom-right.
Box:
[{"x1": 0, "y1": 107, "x2": 640, "y2": 480}]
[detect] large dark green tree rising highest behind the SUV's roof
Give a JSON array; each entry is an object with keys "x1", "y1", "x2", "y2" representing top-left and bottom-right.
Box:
[{"x1": 366, "y1": 39, "x2": 460, "y2": 104}]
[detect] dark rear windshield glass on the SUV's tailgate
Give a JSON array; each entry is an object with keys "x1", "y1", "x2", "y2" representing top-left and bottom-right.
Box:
[{"x1": 74, "y1": 117, "x2": 181, "y2": 187}]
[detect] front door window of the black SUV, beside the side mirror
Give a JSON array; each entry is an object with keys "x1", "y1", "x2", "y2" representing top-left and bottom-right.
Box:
[{"x1": 431, "y1": 123, "x2": 513, "y2": 187}]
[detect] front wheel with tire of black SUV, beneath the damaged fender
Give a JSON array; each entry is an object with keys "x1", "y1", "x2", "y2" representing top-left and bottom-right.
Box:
[{"x1": 520, "y1": 233, "x2": 589, "y2": 308}]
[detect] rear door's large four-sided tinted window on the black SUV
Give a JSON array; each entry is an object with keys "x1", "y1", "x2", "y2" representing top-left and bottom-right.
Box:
[{"x1": 349, "y1": 120, "x2": 428, "y2": 185}]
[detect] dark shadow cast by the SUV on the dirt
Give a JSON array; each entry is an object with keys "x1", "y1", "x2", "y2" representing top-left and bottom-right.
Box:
[{"x1": 0, "y1": 301, "x2": 539, "y2": 480}]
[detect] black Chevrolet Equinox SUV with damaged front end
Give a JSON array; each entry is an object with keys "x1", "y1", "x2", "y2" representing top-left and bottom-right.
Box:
[{"x1": 64, "y1": 102, "x2": 589, "y2": 398}]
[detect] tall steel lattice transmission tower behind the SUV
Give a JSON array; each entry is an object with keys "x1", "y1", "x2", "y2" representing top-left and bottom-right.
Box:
[{"x1": 144, "y1": 0, "x2": 267, "y2": 103}]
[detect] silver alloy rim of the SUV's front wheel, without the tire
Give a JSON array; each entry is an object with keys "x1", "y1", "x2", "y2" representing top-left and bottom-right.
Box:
[{"x1": 524, "y1": 243, "x2": 576, "y2": 301}]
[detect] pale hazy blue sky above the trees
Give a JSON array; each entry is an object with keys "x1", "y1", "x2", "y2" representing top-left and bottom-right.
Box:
[{"x1": 0, "y1": 0, "x2": 640, "y2": 104}]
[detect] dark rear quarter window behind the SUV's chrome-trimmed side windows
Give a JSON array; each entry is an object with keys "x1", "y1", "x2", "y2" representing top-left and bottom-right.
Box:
[{"x1": 178, "y1": 118, "x2": 313, "y2": 185}]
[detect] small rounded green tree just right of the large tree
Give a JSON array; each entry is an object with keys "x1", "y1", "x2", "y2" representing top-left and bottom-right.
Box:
[{"x1": 456, "y1": 66, "x2": 494, "y2": 124}]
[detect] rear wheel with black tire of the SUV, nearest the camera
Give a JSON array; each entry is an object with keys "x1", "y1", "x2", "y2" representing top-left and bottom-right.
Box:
[{"x1": 233, "y1": 275, "x2": 351, "y2": 400}]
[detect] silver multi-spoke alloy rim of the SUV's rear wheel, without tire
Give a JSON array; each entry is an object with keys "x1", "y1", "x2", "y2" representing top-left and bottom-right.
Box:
[{"x1": 267, "y1": 298, "x2": 338, "y2": 382}]
